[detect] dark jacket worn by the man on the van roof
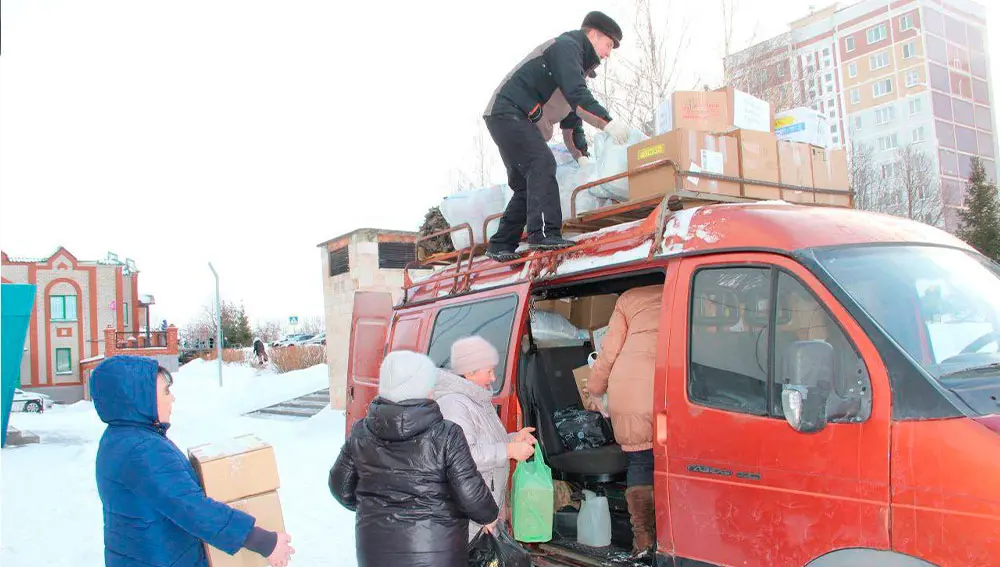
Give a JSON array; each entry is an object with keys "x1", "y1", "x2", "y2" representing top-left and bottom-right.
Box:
[{"x1": 484, "y1": 30, "x2": 611, "y2": 157}]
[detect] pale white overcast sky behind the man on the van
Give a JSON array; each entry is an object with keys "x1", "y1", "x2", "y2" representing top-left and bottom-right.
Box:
[{"x1": 0, "y1": 0, "x2": 1000, "y2": 330}]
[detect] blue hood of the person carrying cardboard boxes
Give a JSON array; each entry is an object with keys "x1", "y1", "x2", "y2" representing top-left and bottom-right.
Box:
[{"x1": 90, "y1": 355, "x2": 166, "y2": 426}]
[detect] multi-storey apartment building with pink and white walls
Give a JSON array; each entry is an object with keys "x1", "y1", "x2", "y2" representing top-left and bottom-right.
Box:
[{"x1": 726, "y1": 0, "x2": 998, "y2": 230}]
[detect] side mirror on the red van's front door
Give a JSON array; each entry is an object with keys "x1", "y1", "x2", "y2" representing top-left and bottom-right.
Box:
[{"x1": 781, "y1": 341, "x2": 833, "y2": 433}]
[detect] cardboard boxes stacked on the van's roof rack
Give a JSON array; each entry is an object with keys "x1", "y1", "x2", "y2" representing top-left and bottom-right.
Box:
[{"x1": 628, "y1": 88, "x2": 851, "y2": 207}]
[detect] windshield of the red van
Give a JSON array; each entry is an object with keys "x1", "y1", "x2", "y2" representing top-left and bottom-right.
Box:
[{"x1": 815, "y1": 246, "x2": 1000, "y2": 388}]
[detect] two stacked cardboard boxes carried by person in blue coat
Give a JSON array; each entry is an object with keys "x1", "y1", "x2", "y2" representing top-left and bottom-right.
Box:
[{"x1": 188, "y1": 435, "x2": 285, "y2": 567}]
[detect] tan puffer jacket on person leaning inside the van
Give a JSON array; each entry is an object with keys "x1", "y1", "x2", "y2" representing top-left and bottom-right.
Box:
[{"x1": 587, "y1": 285, "x2": 663, "y2": 451}]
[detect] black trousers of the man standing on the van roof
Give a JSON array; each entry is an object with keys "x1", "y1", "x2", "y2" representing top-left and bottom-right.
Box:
[{"x1": 486, "y1": 114, "x2": 562, "y2": 250}]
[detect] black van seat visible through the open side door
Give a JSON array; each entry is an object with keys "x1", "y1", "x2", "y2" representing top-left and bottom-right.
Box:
[{"x1": 520, "y1": 346, "x2": 628, "y2": 483}]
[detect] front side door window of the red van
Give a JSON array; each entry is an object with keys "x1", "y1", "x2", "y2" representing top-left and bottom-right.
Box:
[{"x1": 688, "y1": 266, "x2": 871, "y2": 423}]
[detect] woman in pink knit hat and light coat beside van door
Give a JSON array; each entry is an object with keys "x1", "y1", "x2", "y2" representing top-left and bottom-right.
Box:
[{"x1": 434, "y1": 336, "x2": 535, "y2": 540}]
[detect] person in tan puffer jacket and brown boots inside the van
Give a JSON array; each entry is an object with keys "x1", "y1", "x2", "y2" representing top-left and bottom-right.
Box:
[{"x1": 587, "y1": 285, "x2": 663, "y2": 559}]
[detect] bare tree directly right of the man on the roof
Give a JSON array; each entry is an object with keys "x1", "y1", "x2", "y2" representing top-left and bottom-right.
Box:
[{"x1": 594, "y1": 0, "x2": 691, "y2": 135}]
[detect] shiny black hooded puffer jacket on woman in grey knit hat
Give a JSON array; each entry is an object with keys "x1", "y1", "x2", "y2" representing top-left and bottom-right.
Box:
[{"x1": 330, "y1": 398, "x2": 499, "y2": 567}]
